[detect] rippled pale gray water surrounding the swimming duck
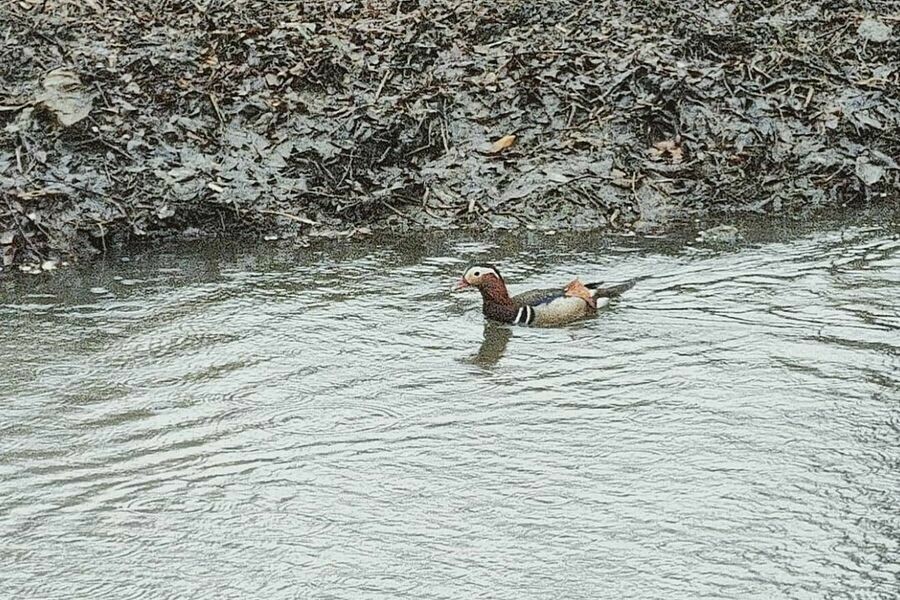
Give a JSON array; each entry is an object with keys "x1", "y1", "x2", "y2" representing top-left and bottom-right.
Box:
[{"x1": 0, "y1": 221, "x2": 900, "y2": 600}]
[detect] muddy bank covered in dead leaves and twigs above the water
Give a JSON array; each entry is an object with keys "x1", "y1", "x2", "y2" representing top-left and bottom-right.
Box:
[{"x1": 0, "y1": 0, "x2": 900, "y2": 266}]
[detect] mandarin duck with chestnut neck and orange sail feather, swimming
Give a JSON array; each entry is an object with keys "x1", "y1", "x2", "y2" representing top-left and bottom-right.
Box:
[{"x1": 453, "y1": 264, "x2": 635, "y2": 327}]
